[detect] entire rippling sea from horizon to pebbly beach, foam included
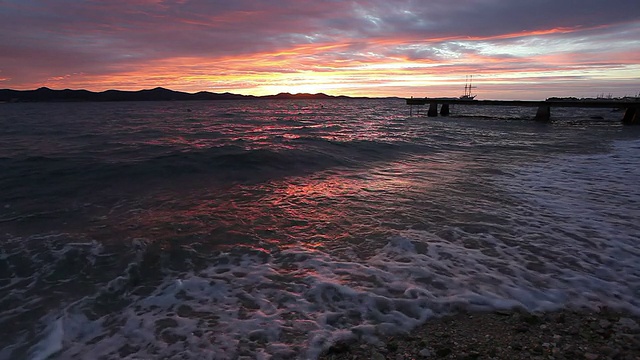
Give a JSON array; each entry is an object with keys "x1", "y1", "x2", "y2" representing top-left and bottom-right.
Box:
[{"x1": 0, "y1": 99, "x2": 640, "y2": 360}]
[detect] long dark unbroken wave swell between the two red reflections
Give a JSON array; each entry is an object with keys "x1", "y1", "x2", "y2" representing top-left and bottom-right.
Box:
[{"x1": 0, "y1": 137, "x2": 429, "y2": 201}]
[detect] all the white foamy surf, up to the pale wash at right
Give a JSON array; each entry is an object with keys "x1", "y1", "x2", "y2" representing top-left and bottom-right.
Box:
[{"x1": 22, "y1": 141, "x2": 640, "y2": 359}]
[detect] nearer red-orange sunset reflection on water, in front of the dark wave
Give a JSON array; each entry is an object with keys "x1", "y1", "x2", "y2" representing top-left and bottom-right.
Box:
[{"x1": 106, "y1": 154, "x2": 465, "y2": 253}]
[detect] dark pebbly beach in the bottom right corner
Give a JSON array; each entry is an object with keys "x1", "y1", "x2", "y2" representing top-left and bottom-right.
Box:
[{"x1": 320, "y1": 308, "x2": 640, "y2": 360}]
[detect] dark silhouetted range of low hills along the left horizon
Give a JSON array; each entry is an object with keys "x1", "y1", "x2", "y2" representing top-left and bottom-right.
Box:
[{"x1": 0, "y1": 87, "x2": 376, "y2": 102}]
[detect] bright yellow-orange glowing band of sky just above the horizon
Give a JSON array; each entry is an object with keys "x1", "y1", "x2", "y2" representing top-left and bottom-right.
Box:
[{"x1": 13, "y1": 22, "x2": 640, "y2": 99}]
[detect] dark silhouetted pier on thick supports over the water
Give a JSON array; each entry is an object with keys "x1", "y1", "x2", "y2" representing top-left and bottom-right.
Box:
[{"x1": 406, "y1": 98, "x2": 640, "y2": 125}]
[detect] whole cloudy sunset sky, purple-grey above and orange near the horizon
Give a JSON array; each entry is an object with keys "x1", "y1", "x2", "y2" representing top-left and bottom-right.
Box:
[{"x1": 0, "y1": 0, "x2": 640, "y2": 99}]
